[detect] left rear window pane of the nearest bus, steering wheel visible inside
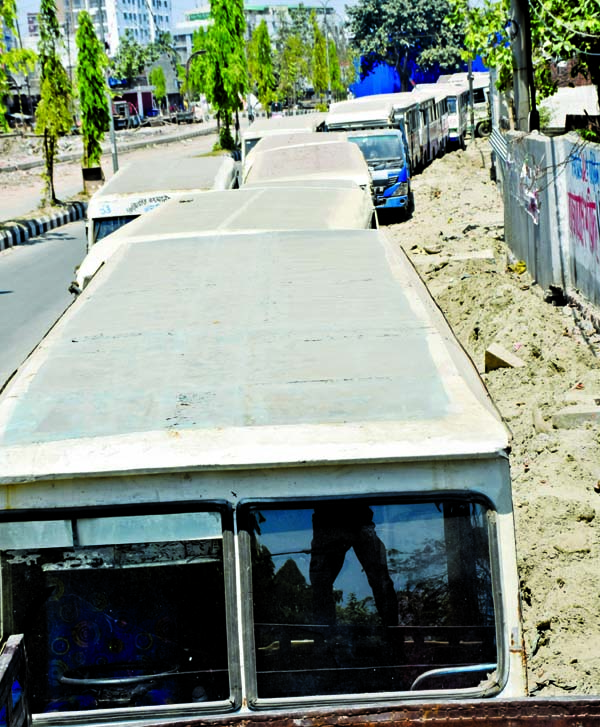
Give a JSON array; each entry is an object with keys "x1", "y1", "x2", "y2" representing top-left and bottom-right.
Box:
[{"x1": 0, "y1": 512, "x2": 230, "y2": 713}]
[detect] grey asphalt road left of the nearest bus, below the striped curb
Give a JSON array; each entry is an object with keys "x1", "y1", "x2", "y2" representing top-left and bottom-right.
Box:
[{"x1": 0, "y1": 222, "x2": 85, "y2": 387}]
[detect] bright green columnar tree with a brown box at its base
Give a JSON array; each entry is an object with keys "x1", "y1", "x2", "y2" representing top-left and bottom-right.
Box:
[{"x1": 76, "y1": 10, "x2": 110, "y2": 167}]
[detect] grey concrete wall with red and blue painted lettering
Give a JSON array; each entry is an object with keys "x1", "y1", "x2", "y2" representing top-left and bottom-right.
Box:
[{"x1": 498, "y1": 132, "x2": 600, "y2": 306}]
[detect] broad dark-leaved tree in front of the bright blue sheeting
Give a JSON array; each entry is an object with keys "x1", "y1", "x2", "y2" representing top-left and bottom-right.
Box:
[{"x1": 348, "y1": 0, "x2": 462, "y2": 90}]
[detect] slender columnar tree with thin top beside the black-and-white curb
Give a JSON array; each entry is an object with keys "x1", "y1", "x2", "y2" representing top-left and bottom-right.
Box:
[{"x1": 35, "y1": 0, "x2": 73, "y2": 205}]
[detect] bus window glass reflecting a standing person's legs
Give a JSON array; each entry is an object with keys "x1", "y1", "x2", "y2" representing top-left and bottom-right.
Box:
[{"x1": 246, "y1": 500, "x2": 497, "y2": 700}]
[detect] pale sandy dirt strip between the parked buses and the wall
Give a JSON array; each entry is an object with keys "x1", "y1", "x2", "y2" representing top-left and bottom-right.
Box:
[{"x1": 388, "y1": 140, "x2": 600, "y2": 696}]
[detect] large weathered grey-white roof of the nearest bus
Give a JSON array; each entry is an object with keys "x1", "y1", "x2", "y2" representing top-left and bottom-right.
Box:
[{"x1": 0, "y1": 230, "x2": 508, "y2": 484}]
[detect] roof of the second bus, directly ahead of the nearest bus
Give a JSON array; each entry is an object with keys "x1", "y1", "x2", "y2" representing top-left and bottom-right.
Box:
[{"x1": 75, "y1": 184, "x2": 375, "y2": 290}]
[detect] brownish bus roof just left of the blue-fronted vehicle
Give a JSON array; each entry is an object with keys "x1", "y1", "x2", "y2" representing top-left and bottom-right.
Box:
[{"x1": 243, "y1": 140, "x2": 371, "y2": 188}]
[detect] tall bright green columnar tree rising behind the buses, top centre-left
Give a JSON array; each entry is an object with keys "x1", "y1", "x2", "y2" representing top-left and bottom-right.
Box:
[{"x1": 209, "y1": 0, "x2": 248, "y2": 149}]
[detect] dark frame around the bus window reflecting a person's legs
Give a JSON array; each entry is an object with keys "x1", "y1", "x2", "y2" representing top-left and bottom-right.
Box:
[{"x1": 236, "y1": 490, "x2": 508, "y2": 712}]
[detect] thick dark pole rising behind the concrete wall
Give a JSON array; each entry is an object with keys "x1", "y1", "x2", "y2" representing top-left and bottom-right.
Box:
[{"x1": 508, "y1": 0, "x2": 540, "y2": 131}]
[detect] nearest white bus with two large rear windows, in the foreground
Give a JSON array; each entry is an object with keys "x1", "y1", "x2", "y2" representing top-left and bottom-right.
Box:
[{"x1": 0, "y1": 219, "x2": 528, "y2": 727}]
